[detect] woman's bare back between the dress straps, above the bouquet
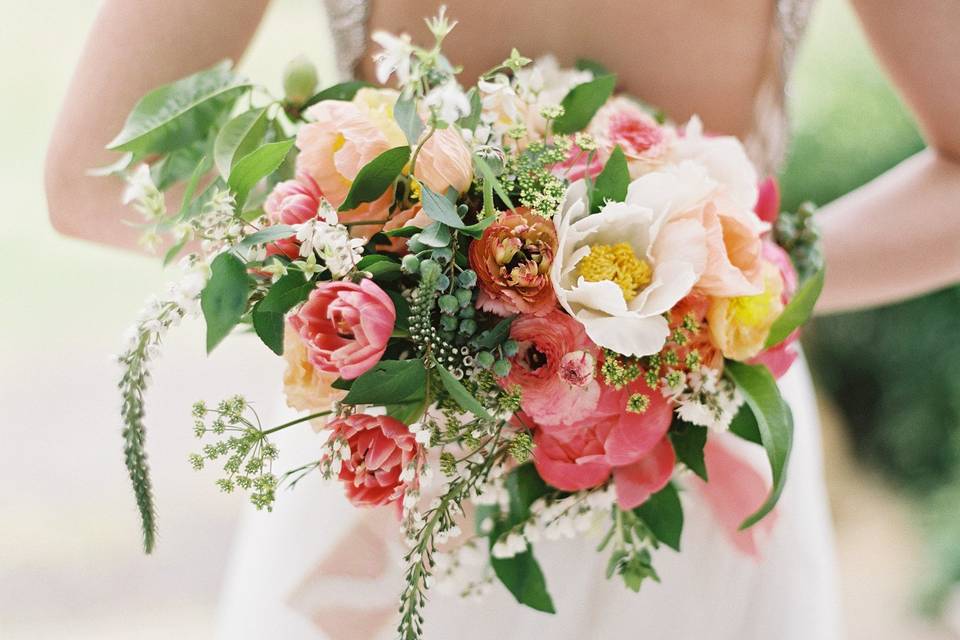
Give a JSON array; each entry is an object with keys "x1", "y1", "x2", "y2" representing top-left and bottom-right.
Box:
[{"x1": 360, "y1": 0, "x2": 778, "y2": 136}]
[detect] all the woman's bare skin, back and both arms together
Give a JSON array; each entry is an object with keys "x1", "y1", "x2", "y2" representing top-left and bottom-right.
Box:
[{"x1": 46, "y1": 0, "x2": 960, "y2": 310}]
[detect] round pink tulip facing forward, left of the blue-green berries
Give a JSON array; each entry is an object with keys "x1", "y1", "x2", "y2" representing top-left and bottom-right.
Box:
[{"x1": 290, "y1": 279, "x2": 397, "y2": 380}]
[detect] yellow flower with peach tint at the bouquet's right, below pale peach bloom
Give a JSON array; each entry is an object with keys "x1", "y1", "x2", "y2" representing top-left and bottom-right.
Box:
[{"x1": 707, "y1": 261, "x2": 783, "y2": 360}]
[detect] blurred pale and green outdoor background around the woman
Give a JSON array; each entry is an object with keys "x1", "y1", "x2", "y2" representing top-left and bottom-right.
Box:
[{"x1": 0, "y1": 0, "x2": 960, "y2": 640}]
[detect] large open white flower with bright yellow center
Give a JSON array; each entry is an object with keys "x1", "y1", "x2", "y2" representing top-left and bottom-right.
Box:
[{"x1": 551, "y1": 170, "x2": 716, "y2": 356}]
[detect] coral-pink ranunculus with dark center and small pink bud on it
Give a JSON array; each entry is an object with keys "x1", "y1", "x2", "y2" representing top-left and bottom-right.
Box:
[{"x1": 503, "y1": 309, "x2": 600, "y2": 425}]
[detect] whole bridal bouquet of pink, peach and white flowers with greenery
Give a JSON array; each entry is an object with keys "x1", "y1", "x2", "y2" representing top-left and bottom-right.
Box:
[{"x1": 110, "y1": 7, "x2": 823, "y2": 638}]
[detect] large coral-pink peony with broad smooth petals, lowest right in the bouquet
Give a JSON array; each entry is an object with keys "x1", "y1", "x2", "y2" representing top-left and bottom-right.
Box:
[{"x1": 533, "y1": 380, "x2": 676, "y2": 509}]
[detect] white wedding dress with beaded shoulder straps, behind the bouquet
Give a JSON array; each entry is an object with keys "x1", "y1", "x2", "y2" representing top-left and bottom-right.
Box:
[{"x1": 218, "y1": 0, "x2": 840, "y2": 640}]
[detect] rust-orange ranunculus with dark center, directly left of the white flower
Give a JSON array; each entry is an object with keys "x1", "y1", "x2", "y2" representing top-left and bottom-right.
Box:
[{"x1": 470, "y1": 209, "x2": 557, "y2": 316}]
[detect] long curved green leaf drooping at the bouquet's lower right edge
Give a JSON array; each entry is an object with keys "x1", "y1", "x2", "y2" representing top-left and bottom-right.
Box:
[{"x1": 724, "y1": 360, "x2": 793, "y2": 529}]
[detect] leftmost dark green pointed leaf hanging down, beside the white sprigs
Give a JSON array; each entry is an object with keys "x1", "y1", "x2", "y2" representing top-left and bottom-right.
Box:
[{"x1": 200, "y1": 253, "x2": 252, "y2": 353}]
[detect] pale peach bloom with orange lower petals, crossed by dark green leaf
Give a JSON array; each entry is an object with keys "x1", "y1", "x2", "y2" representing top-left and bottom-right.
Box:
[{"x1": 296, "y1": 89, "x2": 406, "y2": 238}]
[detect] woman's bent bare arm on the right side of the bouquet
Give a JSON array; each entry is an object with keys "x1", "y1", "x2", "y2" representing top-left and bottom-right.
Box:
[{"x1": 817, "y1": 0, "x2": 960, "y2": 312}]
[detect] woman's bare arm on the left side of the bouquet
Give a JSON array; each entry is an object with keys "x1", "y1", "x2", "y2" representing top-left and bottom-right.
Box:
[{"x1": 45, "y1": 0, "x2": 269, "y2": 247}]
